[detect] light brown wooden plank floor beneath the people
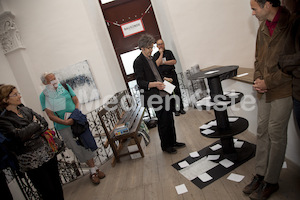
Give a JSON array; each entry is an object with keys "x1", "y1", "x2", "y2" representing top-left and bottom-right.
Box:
[{"x1": 63, "y1": 108, "x2": 300, "y2": 200}]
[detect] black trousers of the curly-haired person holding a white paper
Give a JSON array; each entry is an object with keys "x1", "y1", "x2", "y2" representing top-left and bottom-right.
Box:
[{"x1": 155, "y1": 98, "x2": 176, "y2": 150}]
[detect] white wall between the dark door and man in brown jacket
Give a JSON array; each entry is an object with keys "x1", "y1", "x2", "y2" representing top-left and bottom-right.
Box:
[{"x1": 151, "y1": 0, "x2": 258, "y2": 71}]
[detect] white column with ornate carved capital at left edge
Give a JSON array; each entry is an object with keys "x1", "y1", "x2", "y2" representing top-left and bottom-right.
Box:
[{"x1": 0, "y1": 11, "x2": 42, "y2": 114}]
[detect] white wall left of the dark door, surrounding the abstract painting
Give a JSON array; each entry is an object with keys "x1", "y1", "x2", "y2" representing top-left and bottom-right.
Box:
[{"x1": 0, "y1": 0, "x2": 126, "y2": 111}]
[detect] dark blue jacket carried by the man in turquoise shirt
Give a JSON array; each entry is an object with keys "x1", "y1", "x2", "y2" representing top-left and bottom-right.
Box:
[{"x1": 69, "y1": 109, "x2": 98, "y2": 151}]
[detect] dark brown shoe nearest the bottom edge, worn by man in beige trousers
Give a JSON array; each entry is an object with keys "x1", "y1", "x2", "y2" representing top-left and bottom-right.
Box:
[{"x1": 249, "y1": 181, "x2": 279, "y2": 200}]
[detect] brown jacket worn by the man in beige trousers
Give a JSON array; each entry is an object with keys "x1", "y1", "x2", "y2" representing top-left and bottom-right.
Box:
[{"x1": 254, "y1": 8, "x2": 292, "y2": 102}]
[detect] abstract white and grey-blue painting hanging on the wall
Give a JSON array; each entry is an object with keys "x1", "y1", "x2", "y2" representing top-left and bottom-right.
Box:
[{"x1": 54, "y1": 60, "x2": 100, "y2": 103}]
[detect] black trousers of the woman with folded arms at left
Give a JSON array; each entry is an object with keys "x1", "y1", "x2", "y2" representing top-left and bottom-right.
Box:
[{"x1": 27, "y1": 157, "x2": 64, "y2": 200}]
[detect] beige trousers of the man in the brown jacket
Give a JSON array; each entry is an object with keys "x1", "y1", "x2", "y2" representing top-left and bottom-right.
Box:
[{"x1": 255, "y1": 94, "x2": 293, "y2": 184}]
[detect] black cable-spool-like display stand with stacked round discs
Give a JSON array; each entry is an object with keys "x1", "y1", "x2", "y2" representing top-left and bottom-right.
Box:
[{"x1": 189, "y1": 66, "x2": 255, "y2": 161}]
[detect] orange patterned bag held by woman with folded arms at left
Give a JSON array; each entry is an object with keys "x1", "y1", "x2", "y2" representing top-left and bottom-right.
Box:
[{"x1": 43, "y1": 129, "x2": 65, "y2": 154}]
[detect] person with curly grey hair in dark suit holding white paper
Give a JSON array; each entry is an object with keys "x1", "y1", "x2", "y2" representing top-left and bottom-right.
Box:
[{"x1": 133, "y1": 34, "x2": 186, "y2": 154}]
